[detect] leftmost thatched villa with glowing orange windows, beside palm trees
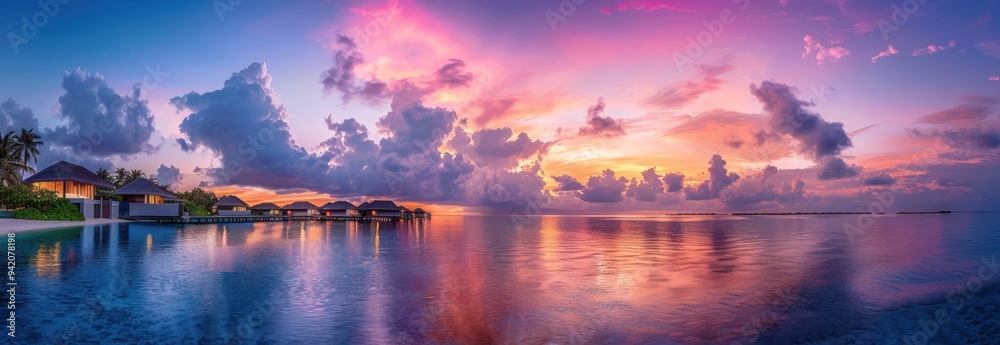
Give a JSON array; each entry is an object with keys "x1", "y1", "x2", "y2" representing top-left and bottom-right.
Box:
[{"x1": 23, "y1": 161, "x2": 118, "y2": 219}]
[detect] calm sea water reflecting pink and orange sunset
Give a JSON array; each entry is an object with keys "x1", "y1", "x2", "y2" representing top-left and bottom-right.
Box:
[{"x1": 11, "y1": 213, "x2": 1000, "y2": 344}]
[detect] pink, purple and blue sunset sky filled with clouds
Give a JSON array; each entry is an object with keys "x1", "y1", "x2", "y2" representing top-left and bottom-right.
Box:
[{"x1": 0, "y1": 0, "x2": 1000, "y2": 215}]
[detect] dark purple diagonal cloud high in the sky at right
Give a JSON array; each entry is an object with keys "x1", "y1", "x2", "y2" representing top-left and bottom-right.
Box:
[{"x1": 750, "y1": 81, "x2": 859, "y2": 179}]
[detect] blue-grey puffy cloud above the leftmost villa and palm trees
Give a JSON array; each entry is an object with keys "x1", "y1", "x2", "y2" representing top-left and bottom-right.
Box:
[{"x1": 44, "y1": 69, "x2": 157, "y2": 157}]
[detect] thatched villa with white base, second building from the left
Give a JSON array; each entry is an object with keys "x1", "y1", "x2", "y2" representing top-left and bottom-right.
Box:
[{"x1": 114, "y1": 178, "x2": 184, "y2": 218}]
